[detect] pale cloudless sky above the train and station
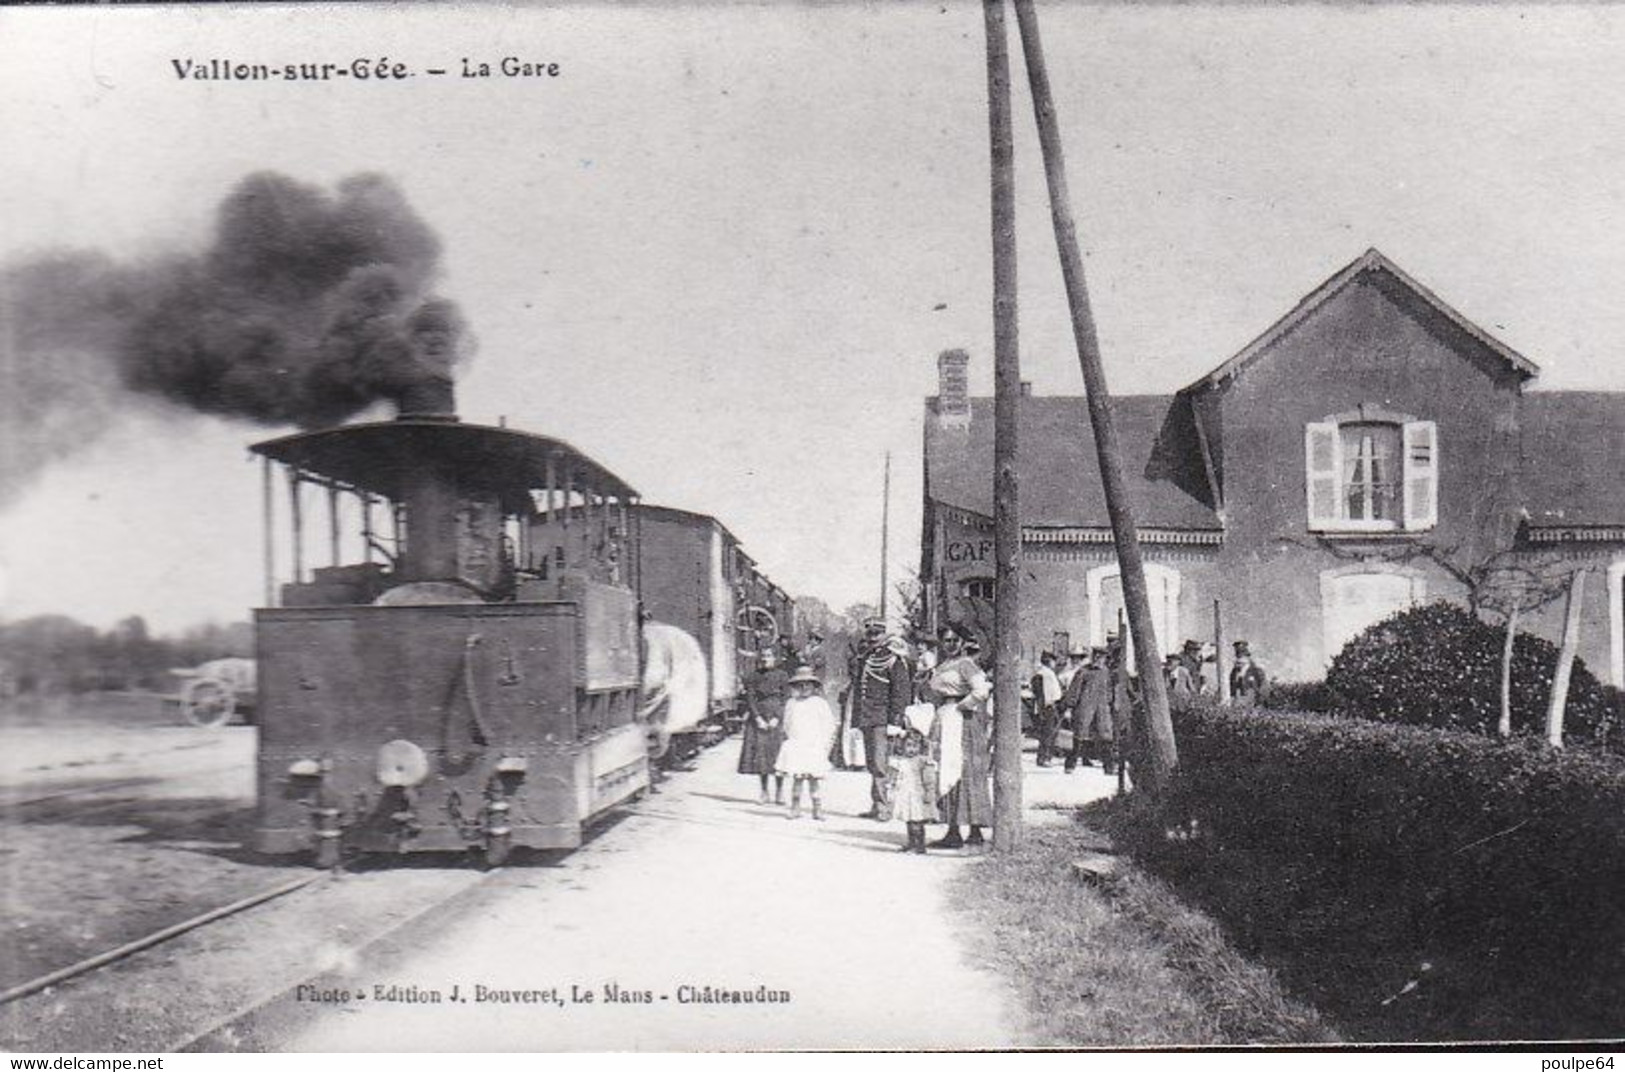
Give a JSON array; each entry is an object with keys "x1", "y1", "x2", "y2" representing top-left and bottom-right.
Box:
[{"x1": 0, "y1": 2, "x2": 1625, "y2": 630}]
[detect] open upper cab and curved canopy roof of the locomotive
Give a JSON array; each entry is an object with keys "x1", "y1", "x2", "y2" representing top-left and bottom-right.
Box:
[{"x1": 250, "y1": 416, "x2": 639, "y2": 606}]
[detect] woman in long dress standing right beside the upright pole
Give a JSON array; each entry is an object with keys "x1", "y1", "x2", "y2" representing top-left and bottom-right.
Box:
[{"x1": 926, "y1": 632, "x2": 993, "y2": 848}]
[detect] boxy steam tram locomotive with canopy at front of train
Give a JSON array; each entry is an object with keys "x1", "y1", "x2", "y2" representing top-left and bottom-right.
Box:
[{"x1": 252, "y1": 397, "x2": 650, "y2": 864}]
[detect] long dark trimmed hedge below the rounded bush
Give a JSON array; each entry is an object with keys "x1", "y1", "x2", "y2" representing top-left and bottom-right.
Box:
[{"x1": 1141, "y1": 707, "x2": 1625, "y2": 1038}]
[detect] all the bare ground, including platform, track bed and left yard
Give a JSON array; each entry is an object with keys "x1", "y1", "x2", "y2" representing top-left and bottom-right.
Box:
[{"x1": 0, "y1": 691, "x2": 1112, "y2": 1053}]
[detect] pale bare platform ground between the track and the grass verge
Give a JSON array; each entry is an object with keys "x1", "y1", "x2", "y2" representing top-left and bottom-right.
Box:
[{"x1": 200, "y1": 741, "x2": 1110, "y2": 1051}]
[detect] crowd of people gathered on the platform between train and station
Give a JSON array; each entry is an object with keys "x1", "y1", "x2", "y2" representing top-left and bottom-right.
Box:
[{"x1": 738, "y1": 617, "x2": 1266, "y2": 853}]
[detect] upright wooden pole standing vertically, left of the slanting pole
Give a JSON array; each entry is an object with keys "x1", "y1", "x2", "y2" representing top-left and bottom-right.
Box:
[{"x1": 982, "y1": 0, "x2": 1022, "y2": 853}]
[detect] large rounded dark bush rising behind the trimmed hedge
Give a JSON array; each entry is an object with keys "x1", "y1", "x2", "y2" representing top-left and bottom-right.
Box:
[{"x1": 1326, "y1": 603, "x2": 1619, "y2": 744}]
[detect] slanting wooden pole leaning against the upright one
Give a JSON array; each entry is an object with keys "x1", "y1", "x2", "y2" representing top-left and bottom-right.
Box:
[{"x1": 1014, "y1": 0, "x2": 1180, "y2": 794}]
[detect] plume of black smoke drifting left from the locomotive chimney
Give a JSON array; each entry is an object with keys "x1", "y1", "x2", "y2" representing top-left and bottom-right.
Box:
[{"x1": 0, "y1": 172, "x2": 471, "y2": 505}]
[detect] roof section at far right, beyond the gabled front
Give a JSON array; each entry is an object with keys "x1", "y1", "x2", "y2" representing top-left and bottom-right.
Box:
[{"x1": 1519, "y1": 391, "x2": 1625, "y2": 528}]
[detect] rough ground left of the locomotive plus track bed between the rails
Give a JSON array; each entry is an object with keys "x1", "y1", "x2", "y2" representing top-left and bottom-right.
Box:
[{"x1": 0, "y1": 695, "x2": 483, "y2": 1053}]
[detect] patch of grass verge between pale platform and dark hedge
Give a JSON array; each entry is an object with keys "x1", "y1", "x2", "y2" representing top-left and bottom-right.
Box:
[{"x1": 949, "y1": 823, "x2": 1337, "y2": 1048}]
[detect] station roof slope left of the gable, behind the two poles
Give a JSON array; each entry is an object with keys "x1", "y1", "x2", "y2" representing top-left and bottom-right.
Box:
[{"x1": 925, "y1": 395, "x2": 1224, "y2": 531}]
